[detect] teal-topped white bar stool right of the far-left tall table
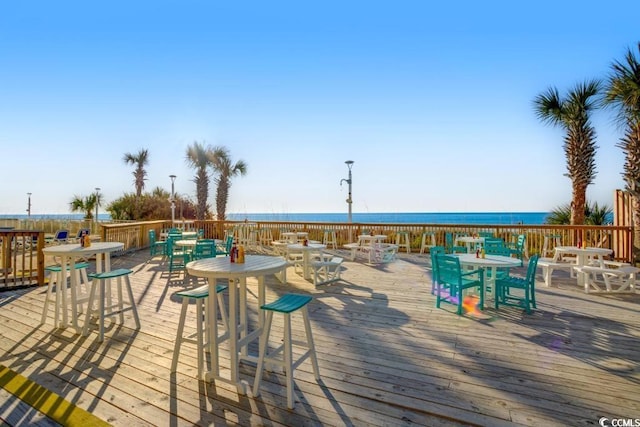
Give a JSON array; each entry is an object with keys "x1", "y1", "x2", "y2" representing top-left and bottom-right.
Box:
[{"x1": 82, "y1": 268, "x2": 140, "y2": 342}]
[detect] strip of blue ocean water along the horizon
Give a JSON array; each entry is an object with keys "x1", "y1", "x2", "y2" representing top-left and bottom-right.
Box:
[{"x1": 0, "y1": 212, "x2": 549, "y2": 225}]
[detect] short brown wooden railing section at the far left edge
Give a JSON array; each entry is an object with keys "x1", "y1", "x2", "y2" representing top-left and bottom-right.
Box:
[{"x1": 0, "y1": 229, "x2": 45, "y2": 290}]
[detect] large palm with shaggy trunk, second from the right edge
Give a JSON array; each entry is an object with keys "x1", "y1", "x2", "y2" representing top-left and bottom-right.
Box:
[{"x1": 534, "y1": 80, "x2": 600, "y2": 225}]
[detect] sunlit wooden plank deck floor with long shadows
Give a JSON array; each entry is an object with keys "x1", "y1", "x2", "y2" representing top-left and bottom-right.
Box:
[{"x1": 0, "y1": 247, "x2": 640, "y2": 426}]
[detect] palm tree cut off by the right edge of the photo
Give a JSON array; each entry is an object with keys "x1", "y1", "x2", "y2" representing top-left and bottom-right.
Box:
[{"x1": 604, "y1": 43, "x2": 640, "y2": 258}]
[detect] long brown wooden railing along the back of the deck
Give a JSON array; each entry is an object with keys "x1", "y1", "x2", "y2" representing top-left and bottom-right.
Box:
[{"x1": 101, "y1": 221, "x2": 633, "y2": 262}]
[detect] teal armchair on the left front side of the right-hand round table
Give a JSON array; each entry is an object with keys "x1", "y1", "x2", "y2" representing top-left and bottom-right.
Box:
[{"x1": 436, "y1": 255, "x2": 484, "y2": 316}]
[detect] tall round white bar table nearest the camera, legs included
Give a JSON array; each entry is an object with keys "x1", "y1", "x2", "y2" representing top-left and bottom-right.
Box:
[{"x1": 187, "y1": 255, "x2": 287, "y2": 394}]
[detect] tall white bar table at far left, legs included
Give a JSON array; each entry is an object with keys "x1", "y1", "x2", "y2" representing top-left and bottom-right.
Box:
[{"x1": 42, "y1": 242, "x2": 124, "y2": 334}]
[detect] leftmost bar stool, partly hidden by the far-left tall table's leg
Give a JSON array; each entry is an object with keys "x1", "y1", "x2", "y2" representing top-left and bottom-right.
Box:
[{"x1": 40, "y1": 262, "x2": 89, "y2": 327}]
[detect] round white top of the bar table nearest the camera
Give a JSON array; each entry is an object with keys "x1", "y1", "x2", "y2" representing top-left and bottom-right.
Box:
[{"x1": 187, "y1": 255, "x2": 287, "y2": 279}]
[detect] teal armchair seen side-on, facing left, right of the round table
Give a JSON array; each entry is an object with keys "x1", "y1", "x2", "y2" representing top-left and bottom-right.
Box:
[{"x1": 495, "y1": 254, "x2": 539, "y2": 314}]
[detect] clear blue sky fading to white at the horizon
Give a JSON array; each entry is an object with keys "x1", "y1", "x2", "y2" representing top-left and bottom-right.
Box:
[{"x1": 0, "y1": 0, "x2": 640, "y2": 214}]
